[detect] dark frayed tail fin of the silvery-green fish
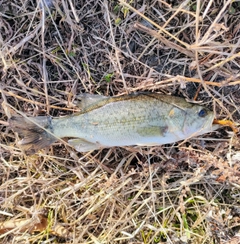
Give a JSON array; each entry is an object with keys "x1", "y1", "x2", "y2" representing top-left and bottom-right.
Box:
[{"x1": 9, "y1": 116, "x2": 57, "y2": 155}]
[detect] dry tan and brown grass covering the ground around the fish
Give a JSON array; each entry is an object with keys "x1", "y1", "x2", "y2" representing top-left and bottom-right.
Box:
[{"x1": 0, "y1": 0, "x2": 240, "y2": 244}]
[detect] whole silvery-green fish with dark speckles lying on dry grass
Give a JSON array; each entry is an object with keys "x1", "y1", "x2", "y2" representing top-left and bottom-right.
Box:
[{"x1": 9, "y1": 92, "x2": 218, "y2": 154}]
